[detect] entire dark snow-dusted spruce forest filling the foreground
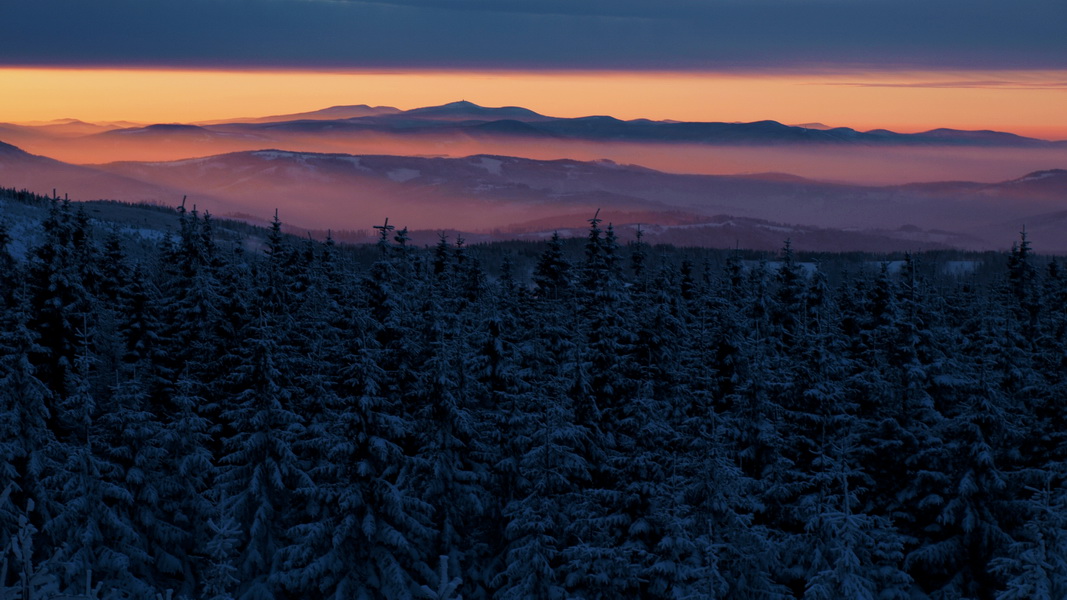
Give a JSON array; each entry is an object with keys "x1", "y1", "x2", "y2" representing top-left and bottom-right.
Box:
[{"x1": 0, "y1": 202, "x2": 1067, "y2": 600}]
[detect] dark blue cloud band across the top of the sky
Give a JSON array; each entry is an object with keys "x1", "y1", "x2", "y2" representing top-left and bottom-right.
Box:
[{"x1": 6, "y1": 0, "x2": 1067, "y2": 70}]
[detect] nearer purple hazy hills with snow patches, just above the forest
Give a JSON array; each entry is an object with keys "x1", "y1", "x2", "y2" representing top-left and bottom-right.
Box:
[{"x1": 0, "y1": 126, "x2": 1067, "y2": 252}]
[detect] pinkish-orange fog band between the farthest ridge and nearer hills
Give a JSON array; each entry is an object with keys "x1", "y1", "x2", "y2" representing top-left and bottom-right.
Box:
[{"x1": 5, "y1": 132, "x2": 1067, "y2": 185}]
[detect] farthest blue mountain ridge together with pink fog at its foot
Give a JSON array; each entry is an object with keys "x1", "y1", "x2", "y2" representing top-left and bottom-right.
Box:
[{"x1": 0, "y1": 101, "x2": 1067, "y2": 178}]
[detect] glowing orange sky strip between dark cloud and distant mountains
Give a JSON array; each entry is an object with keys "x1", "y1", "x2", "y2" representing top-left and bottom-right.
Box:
[{"x1": 0, "y1": 68, "x2": 1067, "y2": 139}]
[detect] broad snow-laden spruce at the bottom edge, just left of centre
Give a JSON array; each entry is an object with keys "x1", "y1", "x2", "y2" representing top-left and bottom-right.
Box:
[{"x1": 280, "y1": 322, "x2": 426, "y2": 599}]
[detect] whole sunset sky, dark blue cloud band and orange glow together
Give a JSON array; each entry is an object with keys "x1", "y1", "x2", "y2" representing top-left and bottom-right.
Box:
[{"x1": 0, "y1": 0, "x2": 1067, "y2": 139}]
